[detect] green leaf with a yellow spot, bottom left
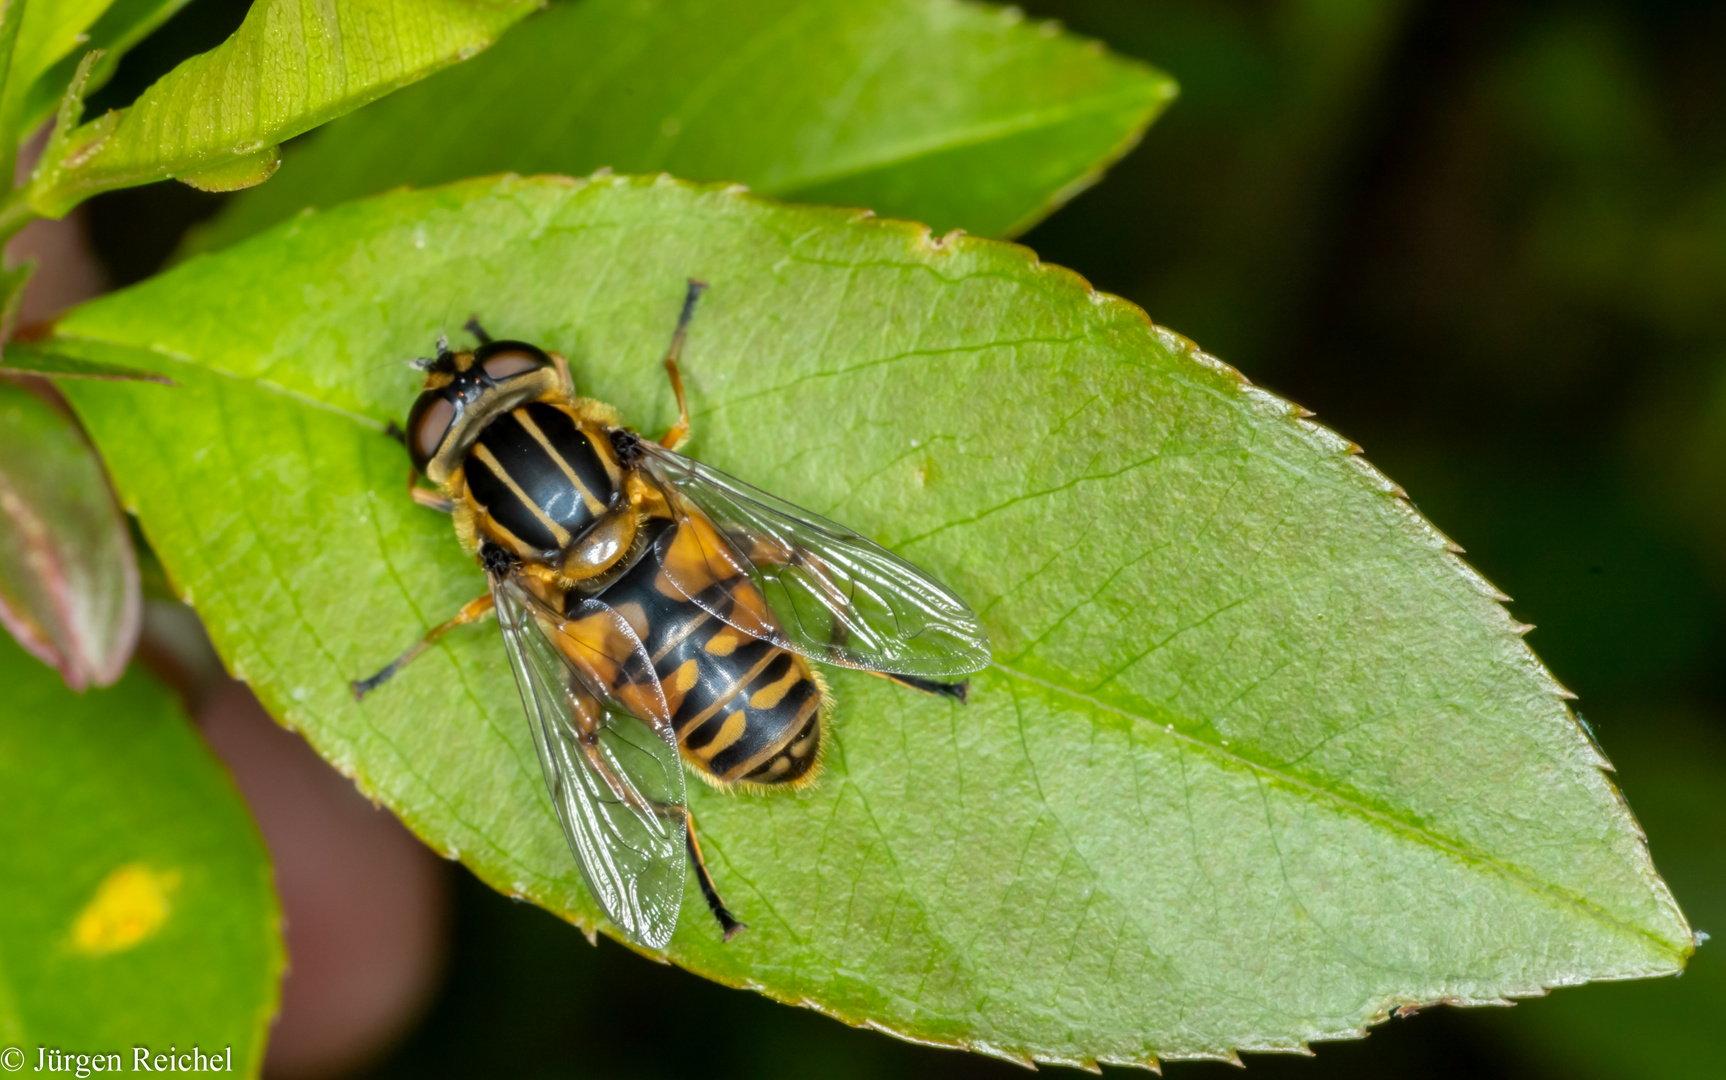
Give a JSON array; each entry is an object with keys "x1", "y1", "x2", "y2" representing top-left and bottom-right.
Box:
[{"x1": 0, "y1": 640, "x2": 281, "y2": 1077}]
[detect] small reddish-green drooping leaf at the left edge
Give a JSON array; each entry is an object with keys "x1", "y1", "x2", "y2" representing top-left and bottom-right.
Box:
[{"x1": 0, "y1": 380, "x2": 140, "y2": 690}]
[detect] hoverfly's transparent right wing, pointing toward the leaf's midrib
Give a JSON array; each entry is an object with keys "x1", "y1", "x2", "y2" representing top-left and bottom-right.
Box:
[{"x1": 640, "y1": 440, "x2": 989, "y2": 676}]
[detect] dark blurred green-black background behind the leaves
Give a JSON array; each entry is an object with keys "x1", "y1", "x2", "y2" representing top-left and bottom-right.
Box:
[{"x1": 86, "y1": 0, "x2": 1726, "y2": 1078}]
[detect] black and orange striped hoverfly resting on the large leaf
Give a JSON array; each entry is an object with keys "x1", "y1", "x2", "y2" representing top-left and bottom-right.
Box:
[{"x1": 352, "y1": 281, "x2": 989, "y2": 949}]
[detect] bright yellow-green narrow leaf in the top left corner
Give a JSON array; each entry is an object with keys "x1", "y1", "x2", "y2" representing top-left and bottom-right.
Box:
[{"x1": 26, "y1": 0, "x2": 539, "y2": 217}]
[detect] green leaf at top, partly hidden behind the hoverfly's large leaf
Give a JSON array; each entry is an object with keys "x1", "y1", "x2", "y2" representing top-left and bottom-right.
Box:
[{"x1": 198, "y1": 0, "x2": 1175, "y2": 247}]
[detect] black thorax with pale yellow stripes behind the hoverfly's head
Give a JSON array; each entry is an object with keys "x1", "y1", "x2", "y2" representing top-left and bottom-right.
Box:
[{"x1": 463, "y1": 402, "x2": 616, "y2": 554}]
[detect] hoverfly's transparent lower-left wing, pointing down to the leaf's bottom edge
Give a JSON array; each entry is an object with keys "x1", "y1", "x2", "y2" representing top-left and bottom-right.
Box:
[{"x1": 492, "y1": 576, "x2": 685, "y2": 949}]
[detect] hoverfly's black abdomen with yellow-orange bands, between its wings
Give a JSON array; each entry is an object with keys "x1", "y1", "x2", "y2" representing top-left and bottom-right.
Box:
[{"x1": 599, "y1": 519, "x2": 827, "y2": 785}]
